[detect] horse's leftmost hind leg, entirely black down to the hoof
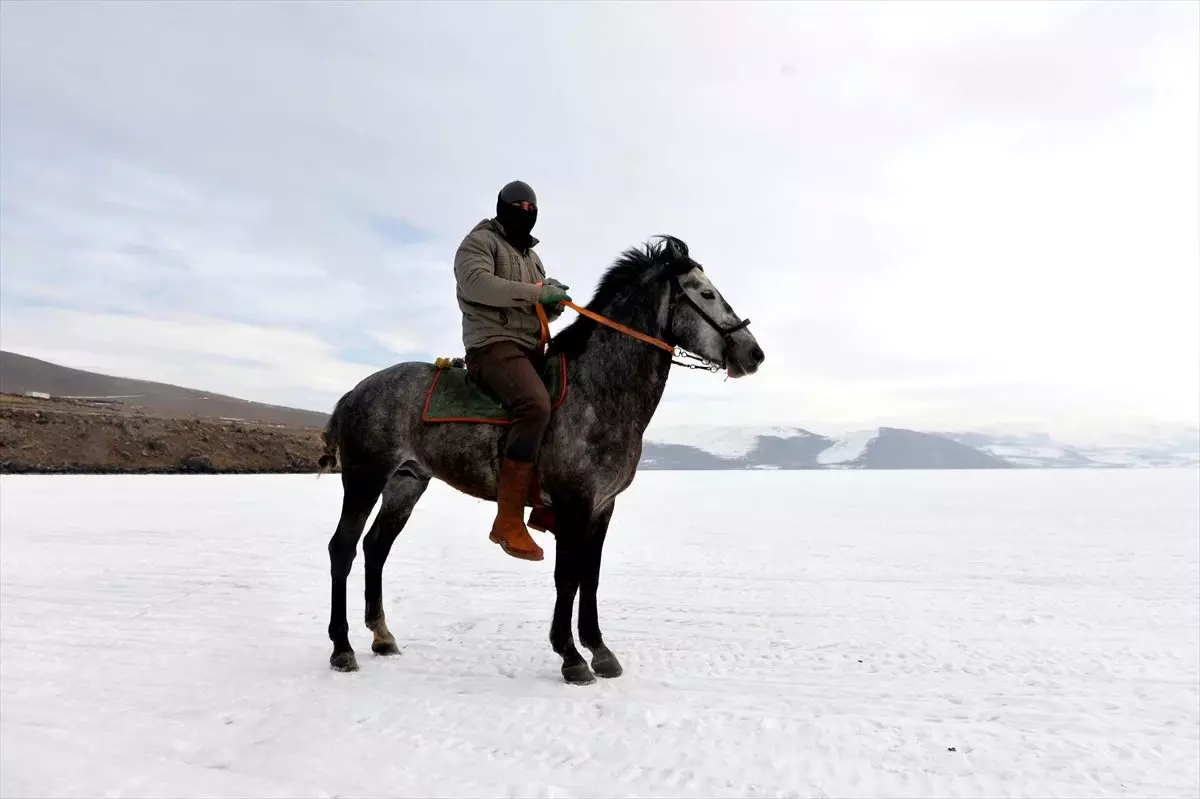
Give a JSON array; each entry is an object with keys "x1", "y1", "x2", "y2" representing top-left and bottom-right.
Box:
[{"x1": 329, "y1": 469, "x2": 386, "y2": 672}]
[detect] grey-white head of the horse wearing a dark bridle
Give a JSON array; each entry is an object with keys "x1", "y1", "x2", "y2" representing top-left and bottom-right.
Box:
[{"x1": 659, "y1": 236, "x2": 767, "y2": 378}]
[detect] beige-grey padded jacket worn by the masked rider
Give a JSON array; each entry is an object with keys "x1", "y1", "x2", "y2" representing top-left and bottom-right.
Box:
[{"x1": 454, "y1": 220, "x2": 562, "y2": 349}]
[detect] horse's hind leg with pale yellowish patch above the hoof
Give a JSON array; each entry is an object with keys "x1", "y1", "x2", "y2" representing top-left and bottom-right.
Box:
[{"x1": 362, "y1": 467, "x2": 430, "y2": 655}]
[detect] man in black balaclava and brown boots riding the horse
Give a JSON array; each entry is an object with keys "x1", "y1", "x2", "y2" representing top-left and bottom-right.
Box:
[{"x1": 454, "y1": 180, "x2": 571, "y2": 560}]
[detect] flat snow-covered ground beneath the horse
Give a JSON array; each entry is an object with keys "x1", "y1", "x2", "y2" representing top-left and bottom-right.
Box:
[{"x1": 0, "y1": 470, "x2": 1200, "y2": 797}]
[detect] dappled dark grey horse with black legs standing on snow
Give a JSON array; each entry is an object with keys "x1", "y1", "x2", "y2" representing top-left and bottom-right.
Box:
[{"x1": 319, "y1": 235, "x2": 766, "y2": 684}]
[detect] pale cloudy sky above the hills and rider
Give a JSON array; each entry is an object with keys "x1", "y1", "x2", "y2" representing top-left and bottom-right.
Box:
[{"x1": 0, "y1": 0, "x2": 1200, "y2": 429}]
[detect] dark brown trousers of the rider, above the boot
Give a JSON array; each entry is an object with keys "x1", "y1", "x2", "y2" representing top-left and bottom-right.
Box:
[{"x1": 466, "y1": 341, "x2": 550, "y2": 463}]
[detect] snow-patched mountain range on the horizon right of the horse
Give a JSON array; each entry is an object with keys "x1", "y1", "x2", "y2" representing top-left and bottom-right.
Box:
[{"x1": 641, "y1": 426, "x2": 1200, "y2": 470}]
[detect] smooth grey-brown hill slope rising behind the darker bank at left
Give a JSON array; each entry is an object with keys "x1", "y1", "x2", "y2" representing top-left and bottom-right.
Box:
[{"x1": 0, "y1": 350, "x2": 328, "y2": 427}]
